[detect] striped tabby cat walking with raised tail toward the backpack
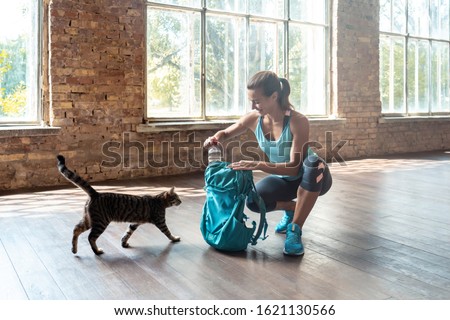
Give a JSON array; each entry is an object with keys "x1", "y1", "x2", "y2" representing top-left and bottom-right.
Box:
[{"x1": 57, "y1": 155, "x2": 181, "y2": 255}]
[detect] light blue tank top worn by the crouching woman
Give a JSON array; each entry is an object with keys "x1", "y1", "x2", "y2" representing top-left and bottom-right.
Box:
[{"x1": 255, "y1": 111, "x2": 303, "y2": 180}]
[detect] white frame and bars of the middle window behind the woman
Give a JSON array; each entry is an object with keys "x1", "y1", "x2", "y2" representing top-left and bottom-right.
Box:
[{"x1": 144, "y1": 0, "x2": 332, "y2": 125}]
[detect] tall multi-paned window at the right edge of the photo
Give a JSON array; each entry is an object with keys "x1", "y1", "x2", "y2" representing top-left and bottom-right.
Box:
[{"x1": 380, "y1": 0, "x2": 450, "y2": 115}]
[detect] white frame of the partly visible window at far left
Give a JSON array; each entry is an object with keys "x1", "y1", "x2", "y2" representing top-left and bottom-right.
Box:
[{"x1": 0, "y1": 0, "x2": 44, "y2": 128}]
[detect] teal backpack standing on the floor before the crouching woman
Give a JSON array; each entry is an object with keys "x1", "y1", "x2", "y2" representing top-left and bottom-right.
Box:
[{"x1": 200, "y1": 161, "x2": 267, "y2": 251}]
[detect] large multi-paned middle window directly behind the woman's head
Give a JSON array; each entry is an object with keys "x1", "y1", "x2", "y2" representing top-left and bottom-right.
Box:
[{"x1": 147, "y1": 0, "x2": 329, "y2": 120}]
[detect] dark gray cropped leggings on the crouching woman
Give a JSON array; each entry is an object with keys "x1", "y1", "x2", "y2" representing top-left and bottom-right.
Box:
[{"x1": 247, "y1": 155, "x2": 333, "y2": 212}]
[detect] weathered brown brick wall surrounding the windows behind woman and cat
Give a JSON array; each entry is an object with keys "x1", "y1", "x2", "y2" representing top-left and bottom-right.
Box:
[{"x1": 0, "y1": 0, "x2": 450, "y2": 190}]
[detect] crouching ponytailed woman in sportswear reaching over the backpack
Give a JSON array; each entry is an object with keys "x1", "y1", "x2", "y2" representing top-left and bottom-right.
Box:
[{"x1": 204, "y1": 71, "x2": 332, "y2": 255}]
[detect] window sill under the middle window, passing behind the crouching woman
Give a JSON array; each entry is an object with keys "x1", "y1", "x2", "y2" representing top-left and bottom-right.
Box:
[{"x1": 136, "y1": 117, "x2": 345, "y2": 133}]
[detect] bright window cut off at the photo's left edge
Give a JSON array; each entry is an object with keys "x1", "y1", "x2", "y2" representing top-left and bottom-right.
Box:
[{"x1": 0, "y1": 0, "x2": 41, "y2": 124}]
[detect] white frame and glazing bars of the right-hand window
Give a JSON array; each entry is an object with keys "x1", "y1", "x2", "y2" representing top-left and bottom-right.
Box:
[{"x1": 379, "y1": 0, "x2": 450, "y2": 117}]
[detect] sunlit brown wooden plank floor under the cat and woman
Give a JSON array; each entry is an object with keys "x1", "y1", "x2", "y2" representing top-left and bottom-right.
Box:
[{"x1": 0, "y1": 152, "x2": 450, "y2": 300}]
